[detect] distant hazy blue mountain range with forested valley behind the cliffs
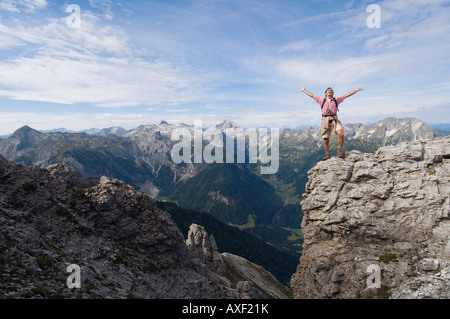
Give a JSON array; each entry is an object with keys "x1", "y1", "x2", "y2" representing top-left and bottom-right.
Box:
[{"x1": 0, "y1": 118, "x2": 438, "y2": 255}]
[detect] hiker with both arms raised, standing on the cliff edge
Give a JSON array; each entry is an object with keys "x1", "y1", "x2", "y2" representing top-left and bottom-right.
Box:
[{"x1": 300, "y1": 87, "x2": 362, "y2": 161}]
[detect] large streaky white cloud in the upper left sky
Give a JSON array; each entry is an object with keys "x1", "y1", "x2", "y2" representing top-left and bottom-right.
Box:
[{"x1": 0, "y1": 12, "x2": 207, "y2": 107}]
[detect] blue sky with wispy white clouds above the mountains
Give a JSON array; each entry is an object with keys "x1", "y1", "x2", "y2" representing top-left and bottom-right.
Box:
[{"x1": 0, "y1": 0, "x2": 450, "y2": 135}]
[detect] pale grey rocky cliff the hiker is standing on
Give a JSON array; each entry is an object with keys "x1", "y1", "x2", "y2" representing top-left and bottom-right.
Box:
[{"x1": 291, "y1": 137, "x2": 450, "y2": 298}]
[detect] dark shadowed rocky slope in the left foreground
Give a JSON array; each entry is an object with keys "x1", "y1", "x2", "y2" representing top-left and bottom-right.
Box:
[{"x1": 0, "y1": 156, "x2": 289, "y2": 299}]
